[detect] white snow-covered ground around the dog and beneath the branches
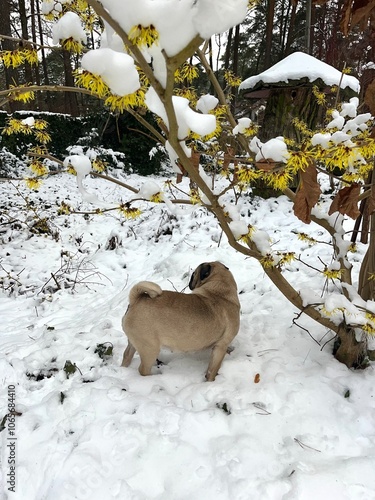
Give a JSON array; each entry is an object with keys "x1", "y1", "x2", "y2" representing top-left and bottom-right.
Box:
[{"x1": 0, "y1": 170, "x2": 375, "y2": 500}]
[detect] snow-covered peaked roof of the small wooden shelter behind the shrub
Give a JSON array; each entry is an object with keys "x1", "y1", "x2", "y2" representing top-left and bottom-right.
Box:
[{"x1": 240, "y1": 52, "x2": 359, "y2": 93}]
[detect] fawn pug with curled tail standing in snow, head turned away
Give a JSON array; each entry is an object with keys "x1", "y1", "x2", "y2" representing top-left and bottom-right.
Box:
[{"x1": 121, "y1": 262, "x2": 240, "y2": 381}]
